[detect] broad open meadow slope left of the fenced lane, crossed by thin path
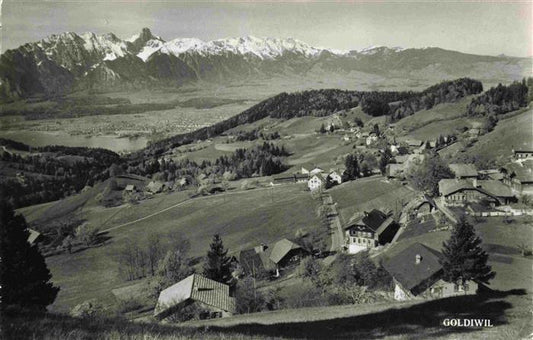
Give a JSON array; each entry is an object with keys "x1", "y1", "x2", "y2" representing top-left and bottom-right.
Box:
[{"x1": 40, "y1": 185, "x2": 320, "y2": 310}]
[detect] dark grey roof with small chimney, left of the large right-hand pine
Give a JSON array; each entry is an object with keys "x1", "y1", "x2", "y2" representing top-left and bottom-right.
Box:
[{"x1": 383, "y1": 243, "x2": 442, "y2": 291}]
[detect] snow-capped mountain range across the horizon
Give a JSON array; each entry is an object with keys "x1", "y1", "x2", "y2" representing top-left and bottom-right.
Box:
[{"x1": 0, "y1": 28, "x2": 531, "y2": 102}]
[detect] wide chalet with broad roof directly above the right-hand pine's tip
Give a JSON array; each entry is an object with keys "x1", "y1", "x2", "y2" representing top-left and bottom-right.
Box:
[{"x1": 439, "y1": 179, "x2": 500, "y2": 206}]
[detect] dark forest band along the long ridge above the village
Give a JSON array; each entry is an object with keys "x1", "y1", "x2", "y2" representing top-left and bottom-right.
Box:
[{"x1": 140, "y1": 78, "x2": 483, "y2": 158}]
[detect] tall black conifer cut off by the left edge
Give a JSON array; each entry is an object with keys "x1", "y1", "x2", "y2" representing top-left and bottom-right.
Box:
[{"x1": 0, "y1": 201, "x2": 59, "y2": 310}]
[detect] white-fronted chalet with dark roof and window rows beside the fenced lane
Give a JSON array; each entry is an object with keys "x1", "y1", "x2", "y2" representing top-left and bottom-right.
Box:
[{"x1": 344, "y1": 209, "x2": 399, "y2": 254}]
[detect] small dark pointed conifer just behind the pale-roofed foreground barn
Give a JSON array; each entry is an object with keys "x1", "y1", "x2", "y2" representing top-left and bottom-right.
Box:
[{"x1": 204, "y1": 234, "x2": 231, "y2": 283}]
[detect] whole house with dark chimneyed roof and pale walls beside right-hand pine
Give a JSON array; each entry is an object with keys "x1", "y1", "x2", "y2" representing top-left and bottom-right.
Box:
[{"x1": 383, "y1": 243, "x2": 478, "y2": 301}]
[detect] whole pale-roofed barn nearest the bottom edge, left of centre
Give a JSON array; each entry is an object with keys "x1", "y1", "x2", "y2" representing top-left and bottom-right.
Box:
[{"x1": 154, "y1": 274, "x2": 235, "y2": 320}]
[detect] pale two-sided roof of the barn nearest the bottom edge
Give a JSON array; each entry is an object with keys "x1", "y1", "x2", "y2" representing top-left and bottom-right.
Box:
[{"x1": 154, "y1": 274, "x2": 235, "y2": 318}]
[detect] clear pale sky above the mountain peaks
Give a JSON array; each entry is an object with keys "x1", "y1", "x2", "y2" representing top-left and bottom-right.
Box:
[{"x1": 0, "y1": 0, "x2": 533, "y2": 57}]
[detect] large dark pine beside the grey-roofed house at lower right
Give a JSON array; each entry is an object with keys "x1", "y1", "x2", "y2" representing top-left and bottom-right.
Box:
[{"x1": 440, "y1": 216, "x2": 496, "y2": 285}]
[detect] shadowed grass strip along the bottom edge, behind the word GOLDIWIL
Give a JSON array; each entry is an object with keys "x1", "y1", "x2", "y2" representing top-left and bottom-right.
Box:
[{"x1": 3, "y1": 290, "x2": 533, "y2": 339}]
